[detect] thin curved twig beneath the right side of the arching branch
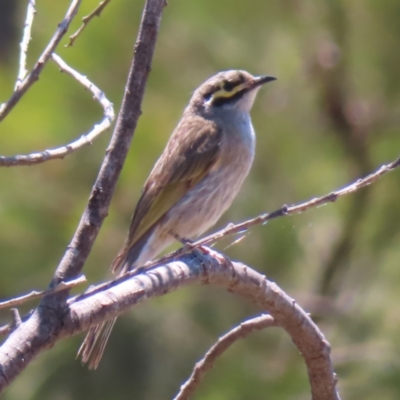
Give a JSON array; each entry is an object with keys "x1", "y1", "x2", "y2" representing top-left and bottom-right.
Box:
[{"x1": 174, "y1": 314, "x2": 276, "y2": 400}]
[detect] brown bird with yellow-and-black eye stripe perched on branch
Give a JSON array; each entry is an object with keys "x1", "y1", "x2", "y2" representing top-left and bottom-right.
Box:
[{"x1": 78, "y1": 70, "x2": 276, "y2": 369}]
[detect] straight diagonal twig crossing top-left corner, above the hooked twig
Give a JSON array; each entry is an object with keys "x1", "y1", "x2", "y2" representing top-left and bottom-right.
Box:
[{"x1": 0, "y1": 0, "x2": 82, "y2": 121}]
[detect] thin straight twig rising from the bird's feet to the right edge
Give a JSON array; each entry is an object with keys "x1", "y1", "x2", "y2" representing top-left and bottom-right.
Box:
[{"x1": 140, "y1": 153, "x2": 400, "y2": 276}]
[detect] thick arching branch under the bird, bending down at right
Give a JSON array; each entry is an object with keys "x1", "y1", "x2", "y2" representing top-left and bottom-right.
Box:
[{"x1": 0, "y1": 251, "x2": 340, "y2": 400}]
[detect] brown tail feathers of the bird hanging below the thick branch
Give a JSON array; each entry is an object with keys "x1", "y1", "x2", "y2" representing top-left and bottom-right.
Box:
[{"x1": 77, "y1": 318, "x2": 117, "y2": 369}]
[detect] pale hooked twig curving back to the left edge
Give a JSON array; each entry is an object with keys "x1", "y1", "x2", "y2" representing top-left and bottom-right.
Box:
[{"x1": 0, "y1": 53, "x2": 115, "y2": 167}]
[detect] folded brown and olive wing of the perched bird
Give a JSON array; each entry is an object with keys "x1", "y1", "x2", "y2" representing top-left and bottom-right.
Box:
[{"x1": 112, "y1": 117, "x2": 222, "y2": 271}]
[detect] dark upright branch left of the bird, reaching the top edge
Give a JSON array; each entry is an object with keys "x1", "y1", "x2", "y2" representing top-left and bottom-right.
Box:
[{"x1": 46, "y1": 0, "x2": 165, "y2": 285}]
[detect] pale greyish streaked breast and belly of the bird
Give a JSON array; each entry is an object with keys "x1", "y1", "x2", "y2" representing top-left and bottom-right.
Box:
[{"x1": 159, "y1": 111, "x2": 255, "y2": 238}]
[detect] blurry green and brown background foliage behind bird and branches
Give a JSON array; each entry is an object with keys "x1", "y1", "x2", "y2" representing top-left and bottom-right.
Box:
[{"x1": 0, "y1": 0, "x2": 400, "y2": 400}]
